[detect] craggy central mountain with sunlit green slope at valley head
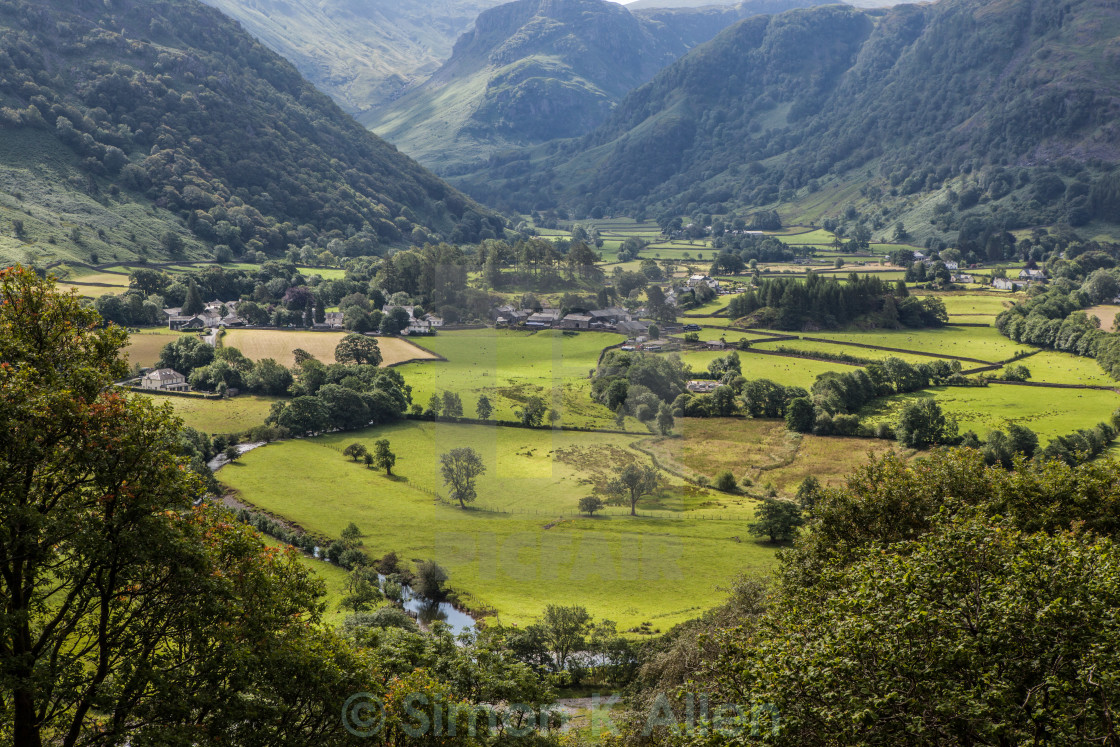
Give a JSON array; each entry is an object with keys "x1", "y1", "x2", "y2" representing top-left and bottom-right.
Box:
[{"x1": 371, "y1": 0, "x2": 824, "y2": 172}]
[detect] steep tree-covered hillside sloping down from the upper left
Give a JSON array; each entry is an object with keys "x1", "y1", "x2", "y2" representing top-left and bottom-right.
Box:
[{"x1": 0, "y1": 0, "x2": 500, "y2": 268}]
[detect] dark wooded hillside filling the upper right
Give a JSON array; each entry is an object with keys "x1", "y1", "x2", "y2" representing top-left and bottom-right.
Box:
[{"x1": 463, "y1": 0, "x2": 1120, "y2": 240}]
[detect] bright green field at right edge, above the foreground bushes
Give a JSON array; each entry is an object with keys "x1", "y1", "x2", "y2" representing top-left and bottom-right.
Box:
[{"x1": 860, "y1": 384, "x2": 1120, "y2": 443}]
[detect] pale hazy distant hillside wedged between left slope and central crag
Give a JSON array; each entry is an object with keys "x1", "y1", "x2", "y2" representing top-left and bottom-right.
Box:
[{"x1": 197, "y1": 0, "x2": 504, "y2": 121}]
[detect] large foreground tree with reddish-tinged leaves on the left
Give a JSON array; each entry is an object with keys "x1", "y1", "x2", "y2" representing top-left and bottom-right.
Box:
[{"x1": 0, "y1": 269, "x2": 382, "y2": 744}]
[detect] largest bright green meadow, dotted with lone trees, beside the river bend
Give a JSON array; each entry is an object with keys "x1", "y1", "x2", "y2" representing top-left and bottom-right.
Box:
[{"x1": 218, "y1": 421, "x2": 773, "y2": 631}]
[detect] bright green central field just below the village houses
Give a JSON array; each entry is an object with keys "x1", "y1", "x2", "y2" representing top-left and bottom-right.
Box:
[{"x1": 398, "y1": 329, "x2": 622, "y2": 427}]
